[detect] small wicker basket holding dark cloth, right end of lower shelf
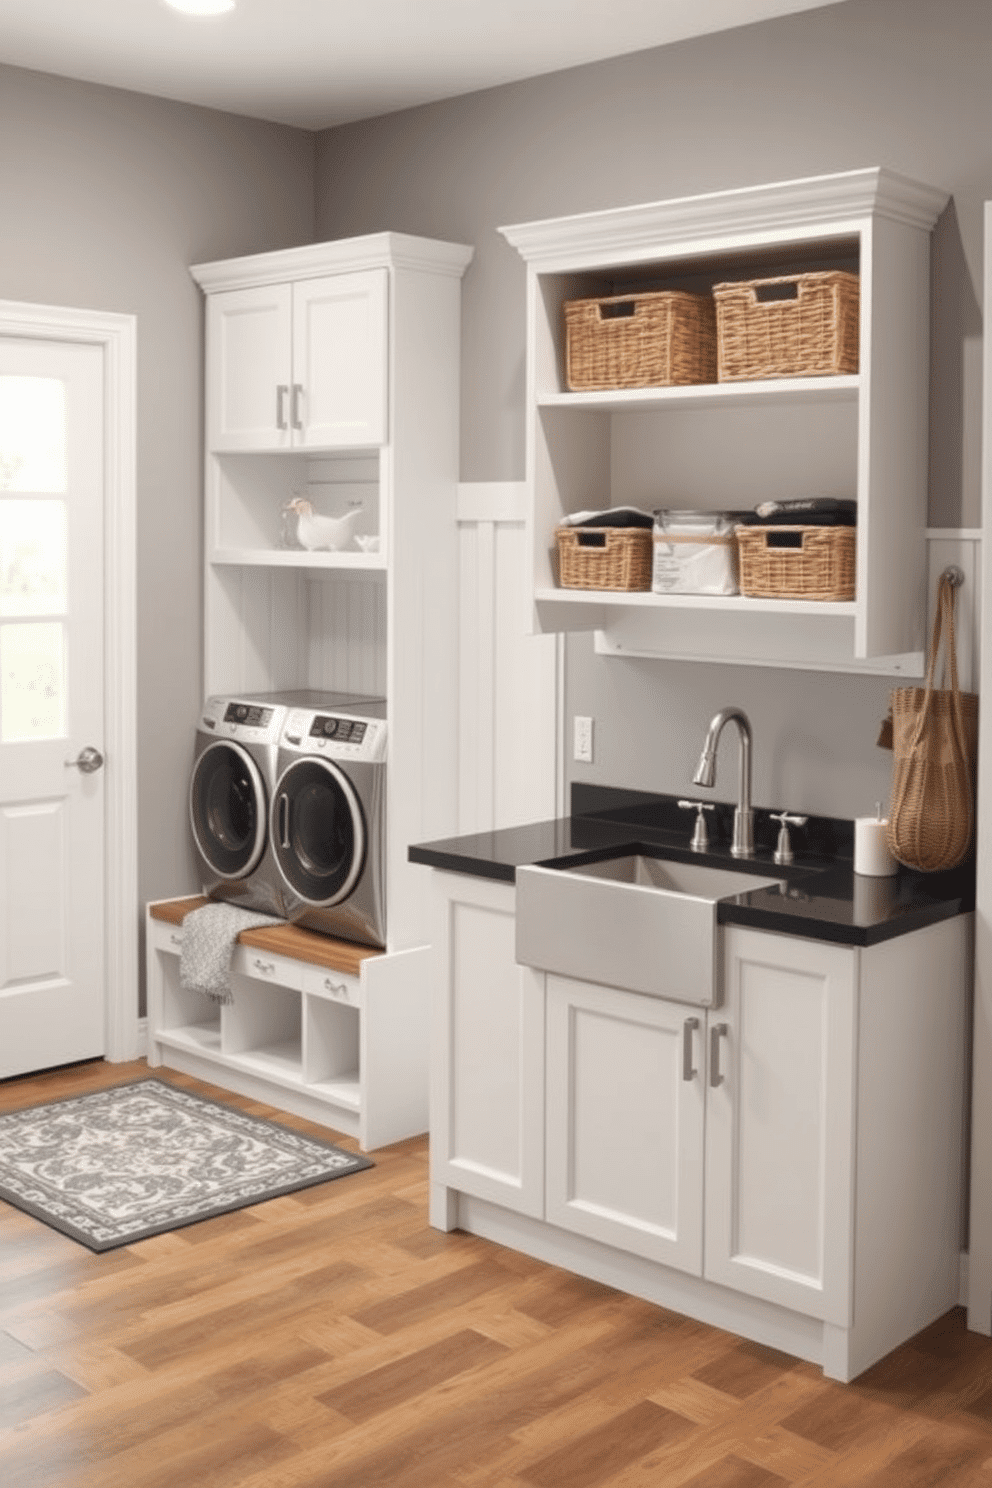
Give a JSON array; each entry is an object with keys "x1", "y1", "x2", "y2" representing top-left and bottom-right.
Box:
[{"x1": 736, "y1": 527, "x2": 855, "y2": 600}]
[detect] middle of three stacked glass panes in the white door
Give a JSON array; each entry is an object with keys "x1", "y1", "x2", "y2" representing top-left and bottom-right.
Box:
[{"x1": 0, "y1": 497, "x2": 67, "y2": 616}]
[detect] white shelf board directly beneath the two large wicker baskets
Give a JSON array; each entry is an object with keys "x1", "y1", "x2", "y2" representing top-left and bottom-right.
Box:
[{"x1": 537, "y1": 373, "x2": 861, "y2": 414}]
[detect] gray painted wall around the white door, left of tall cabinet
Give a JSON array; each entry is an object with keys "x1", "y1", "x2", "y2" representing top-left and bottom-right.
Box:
[{"x1": 0, "y1": 67, "x2": 314, "y2": 1005}]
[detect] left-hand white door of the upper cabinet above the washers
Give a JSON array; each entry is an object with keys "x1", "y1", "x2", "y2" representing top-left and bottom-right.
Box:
[{"x1": 207, "y1": 284, "x2": 293, "y2": 451}]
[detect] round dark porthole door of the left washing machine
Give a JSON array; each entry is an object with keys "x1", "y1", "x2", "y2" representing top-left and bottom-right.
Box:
[{"x1": 189, "y1": 740, "x2": 268, "y2": 879}]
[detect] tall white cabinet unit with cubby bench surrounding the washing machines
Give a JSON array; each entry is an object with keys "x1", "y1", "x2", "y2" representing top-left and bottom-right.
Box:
[{"x1": 147, "y1": 232, "x2": 471, "y2": 1149}]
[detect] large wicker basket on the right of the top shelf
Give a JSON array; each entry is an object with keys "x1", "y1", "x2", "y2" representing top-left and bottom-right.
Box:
[{"x1": 712, "y1": 271, "x2": 860, "y2": 382}]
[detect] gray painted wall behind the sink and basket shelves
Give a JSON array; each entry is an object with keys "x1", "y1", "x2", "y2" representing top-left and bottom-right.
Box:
[{"x1": 317, "y1": 0, "x2": 992, "y2": 815}]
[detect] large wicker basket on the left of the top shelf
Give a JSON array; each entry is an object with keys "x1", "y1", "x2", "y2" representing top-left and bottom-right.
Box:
[{"x1": 565, "y1": 290, "x2": 717, "y2": 393}]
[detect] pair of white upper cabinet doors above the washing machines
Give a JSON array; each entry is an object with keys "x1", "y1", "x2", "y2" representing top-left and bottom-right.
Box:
[{"x1": 207, "y1": 269, "x2": 388, "y2": 452}]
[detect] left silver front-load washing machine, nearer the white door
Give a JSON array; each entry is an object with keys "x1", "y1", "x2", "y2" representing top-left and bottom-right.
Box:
[{"x1": 189, "y1": 689, "x2": 383, "y2": 918}]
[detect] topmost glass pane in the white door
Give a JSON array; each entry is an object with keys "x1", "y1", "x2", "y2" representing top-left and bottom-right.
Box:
[{"x1": 0, "y1": 373, "x2": 65, "y2": 493}]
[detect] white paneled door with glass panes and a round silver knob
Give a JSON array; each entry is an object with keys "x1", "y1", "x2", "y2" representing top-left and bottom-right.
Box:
[{"x1": 0, "y1": 336, "x2": 106, "y2": 1077}]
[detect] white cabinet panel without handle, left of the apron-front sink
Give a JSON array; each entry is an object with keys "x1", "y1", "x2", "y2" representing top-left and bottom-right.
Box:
[{"x1": 430, "y1": 872, "x2": 544, "y2": 1229}]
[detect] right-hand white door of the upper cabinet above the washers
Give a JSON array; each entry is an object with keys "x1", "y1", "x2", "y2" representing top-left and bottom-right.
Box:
[{"x1": 293, "y1": 269, "x2": 387, "y2": 449}]
